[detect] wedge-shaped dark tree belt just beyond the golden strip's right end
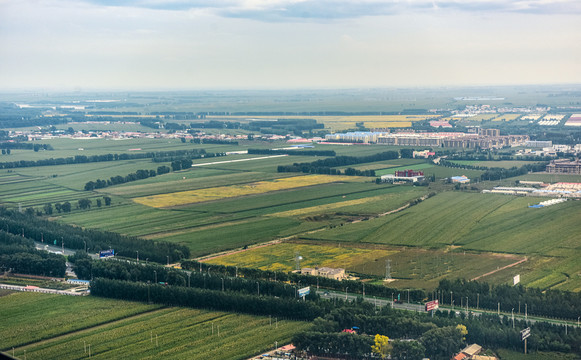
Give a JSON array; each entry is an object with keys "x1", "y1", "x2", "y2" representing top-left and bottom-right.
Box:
[{"x1": 277, "y1": 151, "x2": 400, "y2": 176}]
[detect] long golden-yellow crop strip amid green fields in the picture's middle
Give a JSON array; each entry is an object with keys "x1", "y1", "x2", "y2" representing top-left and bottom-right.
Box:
[{"x1": 133, "y1": 175, "x2": 358, "y2": 208}]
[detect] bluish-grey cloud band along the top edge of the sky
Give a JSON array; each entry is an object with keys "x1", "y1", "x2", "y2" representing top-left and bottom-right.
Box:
[{"x1": 80, "y1": 0, "x2": 581, "y2": 21}]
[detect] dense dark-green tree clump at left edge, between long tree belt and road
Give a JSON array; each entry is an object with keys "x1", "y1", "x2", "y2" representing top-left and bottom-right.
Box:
[{"x1": 0, "y1": 230, "x2": 66, "y2": 277}]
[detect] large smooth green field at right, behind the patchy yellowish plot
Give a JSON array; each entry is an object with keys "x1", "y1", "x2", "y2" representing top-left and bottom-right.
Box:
[{"x1": 302, "y1": 192, "x2": 581, "y2": 291}]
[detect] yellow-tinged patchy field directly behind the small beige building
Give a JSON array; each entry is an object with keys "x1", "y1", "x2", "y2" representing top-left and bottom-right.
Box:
[{"x1": 206, "y1": 243, "x2": 399, "y2": 271}]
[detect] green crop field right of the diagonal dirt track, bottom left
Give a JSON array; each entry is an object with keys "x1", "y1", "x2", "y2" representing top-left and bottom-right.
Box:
[{"x1": 9, "y1": 296, "x2": 309, "y2": 359}]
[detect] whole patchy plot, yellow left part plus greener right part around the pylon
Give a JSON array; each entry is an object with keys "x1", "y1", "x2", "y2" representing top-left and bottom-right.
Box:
[{"x1": 207, "y1": 241, "x2": 522, "y2": 289}]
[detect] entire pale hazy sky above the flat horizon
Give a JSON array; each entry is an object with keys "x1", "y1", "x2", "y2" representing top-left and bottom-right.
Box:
[{"x1": 0, "y1": 0, "x2": 581, "y2": 90}]
